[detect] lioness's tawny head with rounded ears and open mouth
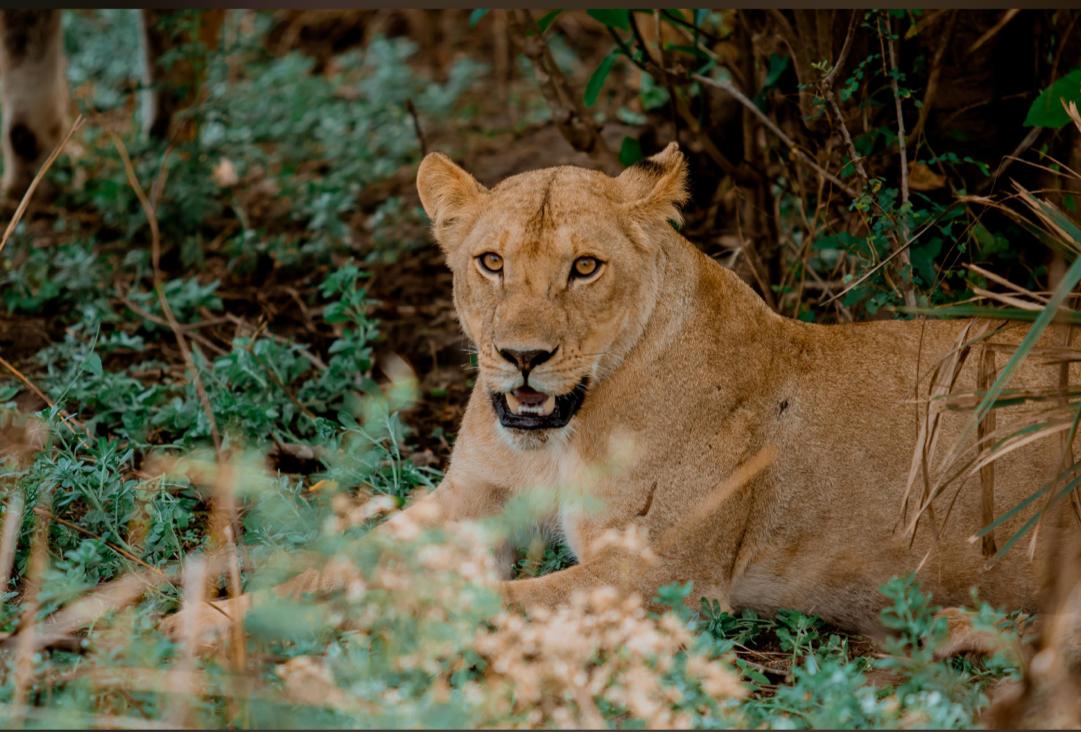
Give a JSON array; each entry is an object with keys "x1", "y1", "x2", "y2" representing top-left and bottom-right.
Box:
[{"x1": 417, "y1": 146, "x2": 685, "y2": 448}]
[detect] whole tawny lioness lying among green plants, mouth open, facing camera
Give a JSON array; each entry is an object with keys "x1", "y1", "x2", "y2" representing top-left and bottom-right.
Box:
[{"x1": 405, "y1": 142, "x2": 1066, "y2": 631}]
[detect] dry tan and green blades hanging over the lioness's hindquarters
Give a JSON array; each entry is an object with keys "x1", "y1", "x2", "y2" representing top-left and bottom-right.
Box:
[{"x1": 902, "y1": 105, "x2": 1081, "y2": 557}]
